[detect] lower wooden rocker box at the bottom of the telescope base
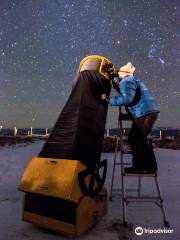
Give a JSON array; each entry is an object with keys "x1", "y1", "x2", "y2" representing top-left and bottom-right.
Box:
[{"x1": 23, "y1": 188, "x2": 107, "y2": 236}]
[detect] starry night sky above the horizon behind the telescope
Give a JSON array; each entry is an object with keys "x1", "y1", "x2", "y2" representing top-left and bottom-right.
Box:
[{"x1": 0, "y1": 0, "x2": 180, "y2": 127}]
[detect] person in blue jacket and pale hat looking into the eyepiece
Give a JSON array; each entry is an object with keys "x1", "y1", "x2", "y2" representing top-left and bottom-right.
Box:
[{"x1": 109, "y1": 63, "x2": 159, "y2": 173}]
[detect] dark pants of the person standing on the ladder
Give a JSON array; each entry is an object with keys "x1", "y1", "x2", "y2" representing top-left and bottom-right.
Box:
[{"x1": 128, "y1": 113, "x2": 158, "y2": 170}]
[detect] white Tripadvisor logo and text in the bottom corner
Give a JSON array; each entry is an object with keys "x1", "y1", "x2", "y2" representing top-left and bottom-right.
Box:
[{"x1": 135, "y1": 227, "x2": 174, "y2": 236}]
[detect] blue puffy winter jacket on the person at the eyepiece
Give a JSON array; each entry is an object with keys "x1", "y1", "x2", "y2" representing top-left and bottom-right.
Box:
[{"x1": 109, "y1": 76, "x2": 159, "y2": 118}]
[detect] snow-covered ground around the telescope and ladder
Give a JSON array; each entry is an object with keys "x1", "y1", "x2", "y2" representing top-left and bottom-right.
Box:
[{"x1": 0, "y1": 141, "x2": 180, "y2": 240}]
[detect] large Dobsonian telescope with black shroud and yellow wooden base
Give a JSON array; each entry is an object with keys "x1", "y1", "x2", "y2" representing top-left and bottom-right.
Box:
[{"x1": 19, "y1": 55, "x2": 115, "y2": 235}]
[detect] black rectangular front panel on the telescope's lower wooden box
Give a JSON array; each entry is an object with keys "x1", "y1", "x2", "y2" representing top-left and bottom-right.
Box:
[{"x1": 24, "y1": 193, "x2": 77, "y2": 224}]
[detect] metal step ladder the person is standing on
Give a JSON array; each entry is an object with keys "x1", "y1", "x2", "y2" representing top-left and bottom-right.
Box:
[{"x1": 109, "y1": 107, "x2": 170, "y2": 227}]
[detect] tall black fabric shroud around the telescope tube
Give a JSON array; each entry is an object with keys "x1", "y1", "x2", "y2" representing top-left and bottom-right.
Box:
[{"x1": 39, "y1": 70, "x2": 111, "y2": 167}]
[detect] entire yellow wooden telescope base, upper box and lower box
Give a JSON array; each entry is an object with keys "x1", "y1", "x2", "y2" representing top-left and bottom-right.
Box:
[{"x1": 19, "y1": 157, "x2": 107, "y2": 236}]
